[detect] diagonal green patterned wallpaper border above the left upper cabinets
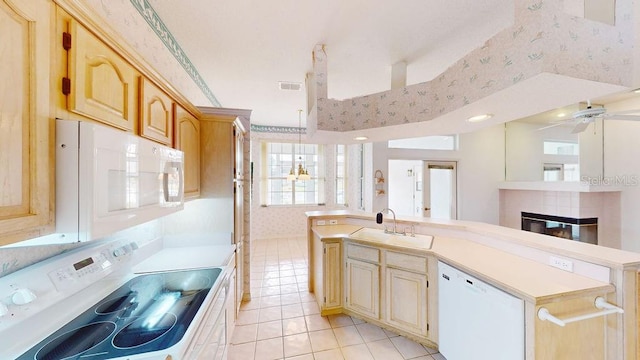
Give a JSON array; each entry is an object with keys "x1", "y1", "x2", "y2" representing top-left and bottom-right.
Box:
[{"x1": 131, "y1": 0, "x2": 222, "y2": 107}]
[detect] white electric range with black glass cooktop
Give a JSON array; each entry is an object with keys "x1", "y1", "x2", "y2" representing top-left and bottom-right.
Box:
[{"x1": 0, "y1": 235, "x2": 233, "y2": 360}]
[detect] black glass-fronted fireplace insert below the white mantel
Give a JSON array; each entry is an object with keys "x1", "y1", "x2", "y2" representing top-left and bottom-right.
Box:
[{"x1": 521, "y1": 211, "x2": 598, "y2": 245}]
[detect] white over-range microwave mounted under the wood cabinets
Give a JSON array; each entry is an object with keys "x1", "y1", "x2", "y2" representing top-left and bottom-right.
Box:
[{"x1": 56, "y1": 120, "x2": 184, "y2": 242}]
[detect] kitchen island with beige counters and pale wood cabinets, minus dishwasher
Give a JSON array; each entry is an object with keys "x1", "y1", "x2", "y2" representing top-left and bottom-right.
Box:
[{"x1": 307, "y1": 211, "x2": 640, "y2": 359}]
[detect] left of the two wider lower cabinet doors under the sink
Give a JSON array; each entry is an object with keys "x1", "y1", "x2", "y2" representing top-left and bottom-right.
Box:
[{"x1": 345, "y1": 259, "x2": 380, "y2": 319}]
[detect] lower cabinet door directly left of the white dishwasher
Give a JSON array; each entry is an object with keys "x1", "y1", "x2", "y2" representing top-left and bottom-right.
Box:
[{"x1": 385, "y1": 268, "x2": 427, "y2": 336}]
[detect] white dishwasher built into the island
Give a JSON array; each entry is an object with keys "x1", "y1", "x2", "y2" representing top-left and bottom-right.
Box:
[{"x1": 438, "y1": 261, "x2": 525, "y2": 360}]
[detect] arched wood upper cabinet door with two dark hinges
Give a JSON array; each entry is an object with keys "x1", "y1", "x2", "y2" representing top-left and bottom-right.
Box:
[{"x1": 63, "y1": 20, "x2": 138, "y2": 131}]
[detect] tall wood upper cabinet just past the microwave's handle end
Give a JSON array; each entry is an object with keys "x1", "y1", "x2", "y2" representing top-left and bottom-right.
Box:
[{"x1": 173, "y1": 104, "x2": 200, "y2": 198}]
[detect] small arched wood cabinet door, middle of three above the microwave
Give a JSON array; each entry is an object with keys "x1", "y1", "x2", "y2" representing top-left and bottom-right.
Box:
[{"x1": 140, "y1": 77, "x2": 173, "y2": 146}]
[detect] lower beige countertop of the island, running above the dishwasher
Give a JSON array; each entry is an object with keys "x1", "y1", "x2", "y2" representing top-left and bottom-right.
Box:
[{"x1": 311, "y1": 225, "x2": 615, "y2": 305}]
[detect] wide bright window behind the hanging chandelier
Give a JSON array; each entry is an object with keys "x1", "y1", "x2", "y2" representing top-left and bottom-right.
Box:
[{"x1": 261, "y1": 143, "x2": 324, "y2": 205}]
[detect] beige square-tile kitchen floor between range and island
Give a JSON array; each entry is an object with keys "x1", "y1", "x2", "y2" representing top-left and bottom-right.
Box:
[{"x1": 228, "y1": 238, "x2": 446, "y2": 360}]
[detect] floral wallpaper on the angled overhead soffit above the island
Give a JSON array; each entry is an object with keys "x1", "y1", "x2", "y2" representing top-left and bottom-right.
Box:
[{"x1": 308, "y1": 0, "x2": 633, "y2": 133}]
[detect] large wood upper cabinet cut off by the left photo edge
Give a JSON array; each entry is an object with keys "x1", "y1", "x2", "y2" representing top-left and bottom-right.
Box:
[{"x1": 0, "y1": 0, "x2": 53, "y2": 245}]
